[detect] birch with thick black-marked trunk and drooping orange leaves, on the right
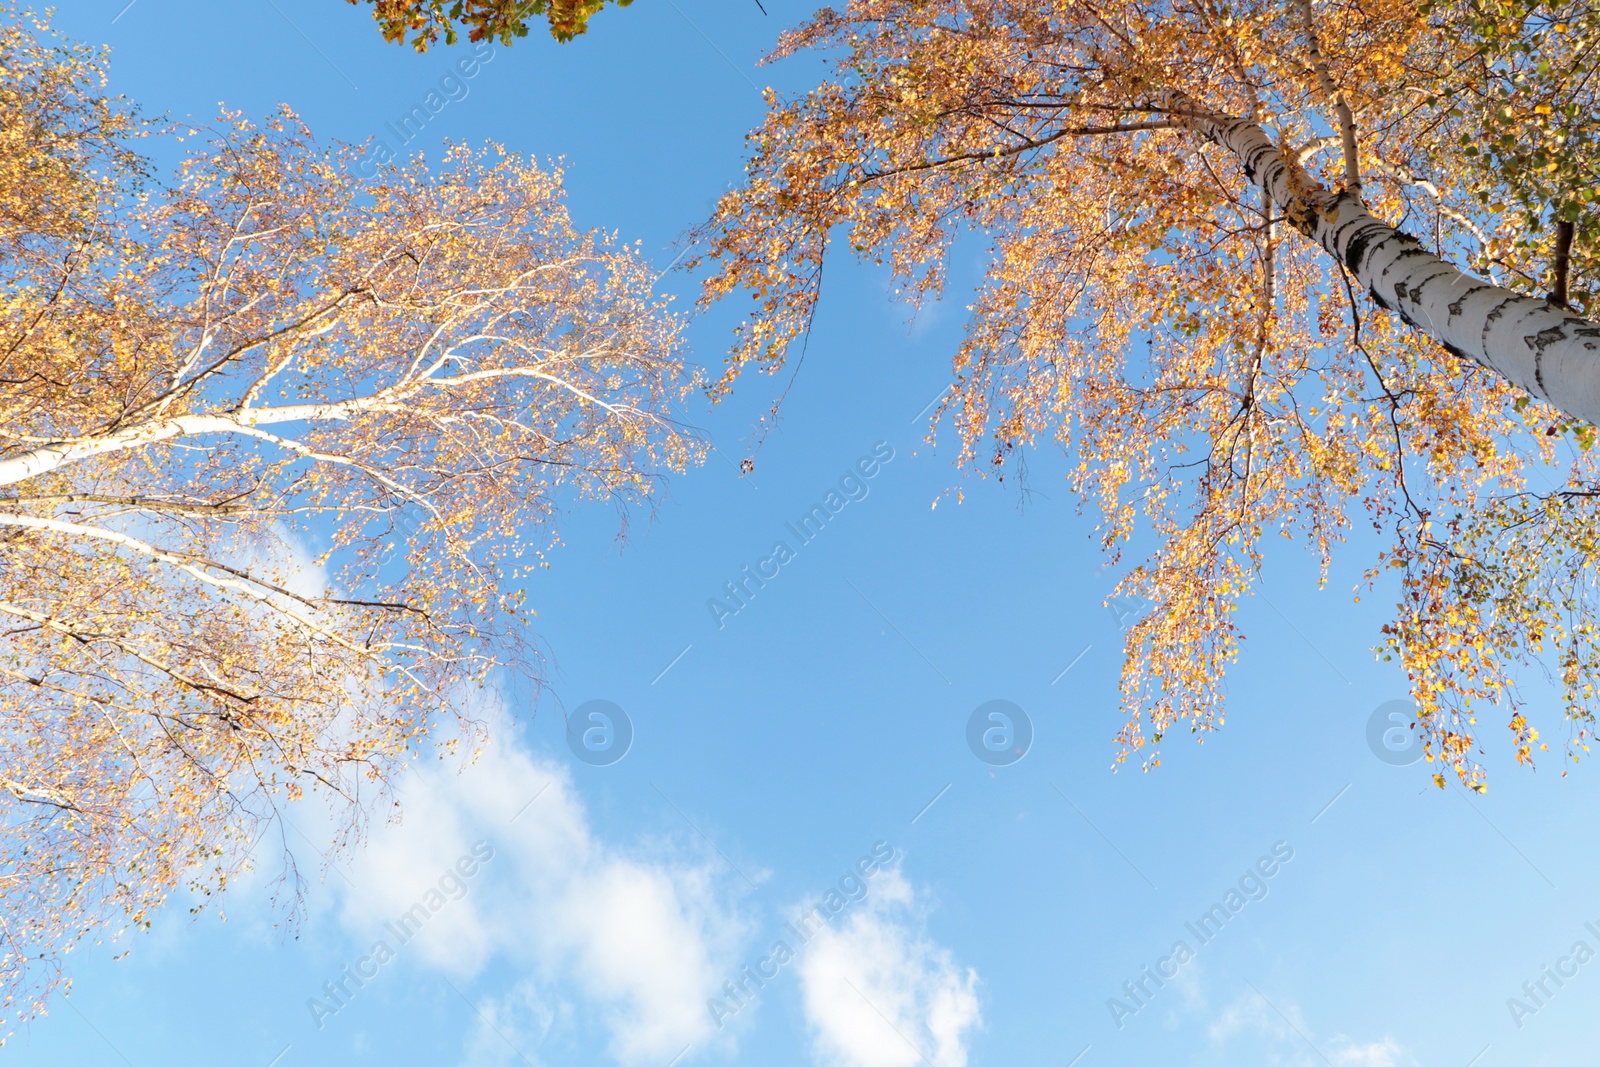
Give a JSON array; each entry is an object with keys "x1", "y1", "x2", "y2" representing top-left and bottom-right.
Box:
[{"x1": 701, "y1": 0, "x2": 1600, "y2": 789}]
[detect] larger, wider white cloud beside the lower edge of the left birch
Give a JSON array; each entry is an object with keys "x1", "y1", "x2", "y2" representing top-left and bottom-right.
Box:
[{"x1": 326, "y1": 700, "x2": 747, "y2": 1067}]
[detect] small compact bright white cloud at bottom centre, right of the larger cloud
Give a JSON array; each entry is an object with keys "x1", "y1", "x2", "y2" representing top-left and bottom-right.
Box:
[{"x1": 800, "y1": 870, "x2": 982, "y2": 1067}]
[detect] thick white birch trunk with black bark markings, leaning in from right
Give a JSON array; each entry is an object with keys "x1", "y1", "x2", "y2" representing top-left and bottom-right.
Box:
[{"x1": 1178, "y1": 109, "x2": 1600, "y2": 424}]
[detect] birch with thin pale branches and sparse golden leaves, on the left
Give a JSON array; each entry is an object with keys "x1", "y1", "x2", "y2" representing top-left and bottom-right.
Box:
[{"x1": 0, "y1": 6, "x2": 698, "y2": 1021}]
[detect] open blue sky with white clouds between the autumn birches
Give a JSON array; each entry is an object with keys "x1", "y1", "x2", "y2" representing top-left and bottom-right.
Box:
[{"x1": 12, "y1": 0, "x2": 1600, "y2": 1067}]
